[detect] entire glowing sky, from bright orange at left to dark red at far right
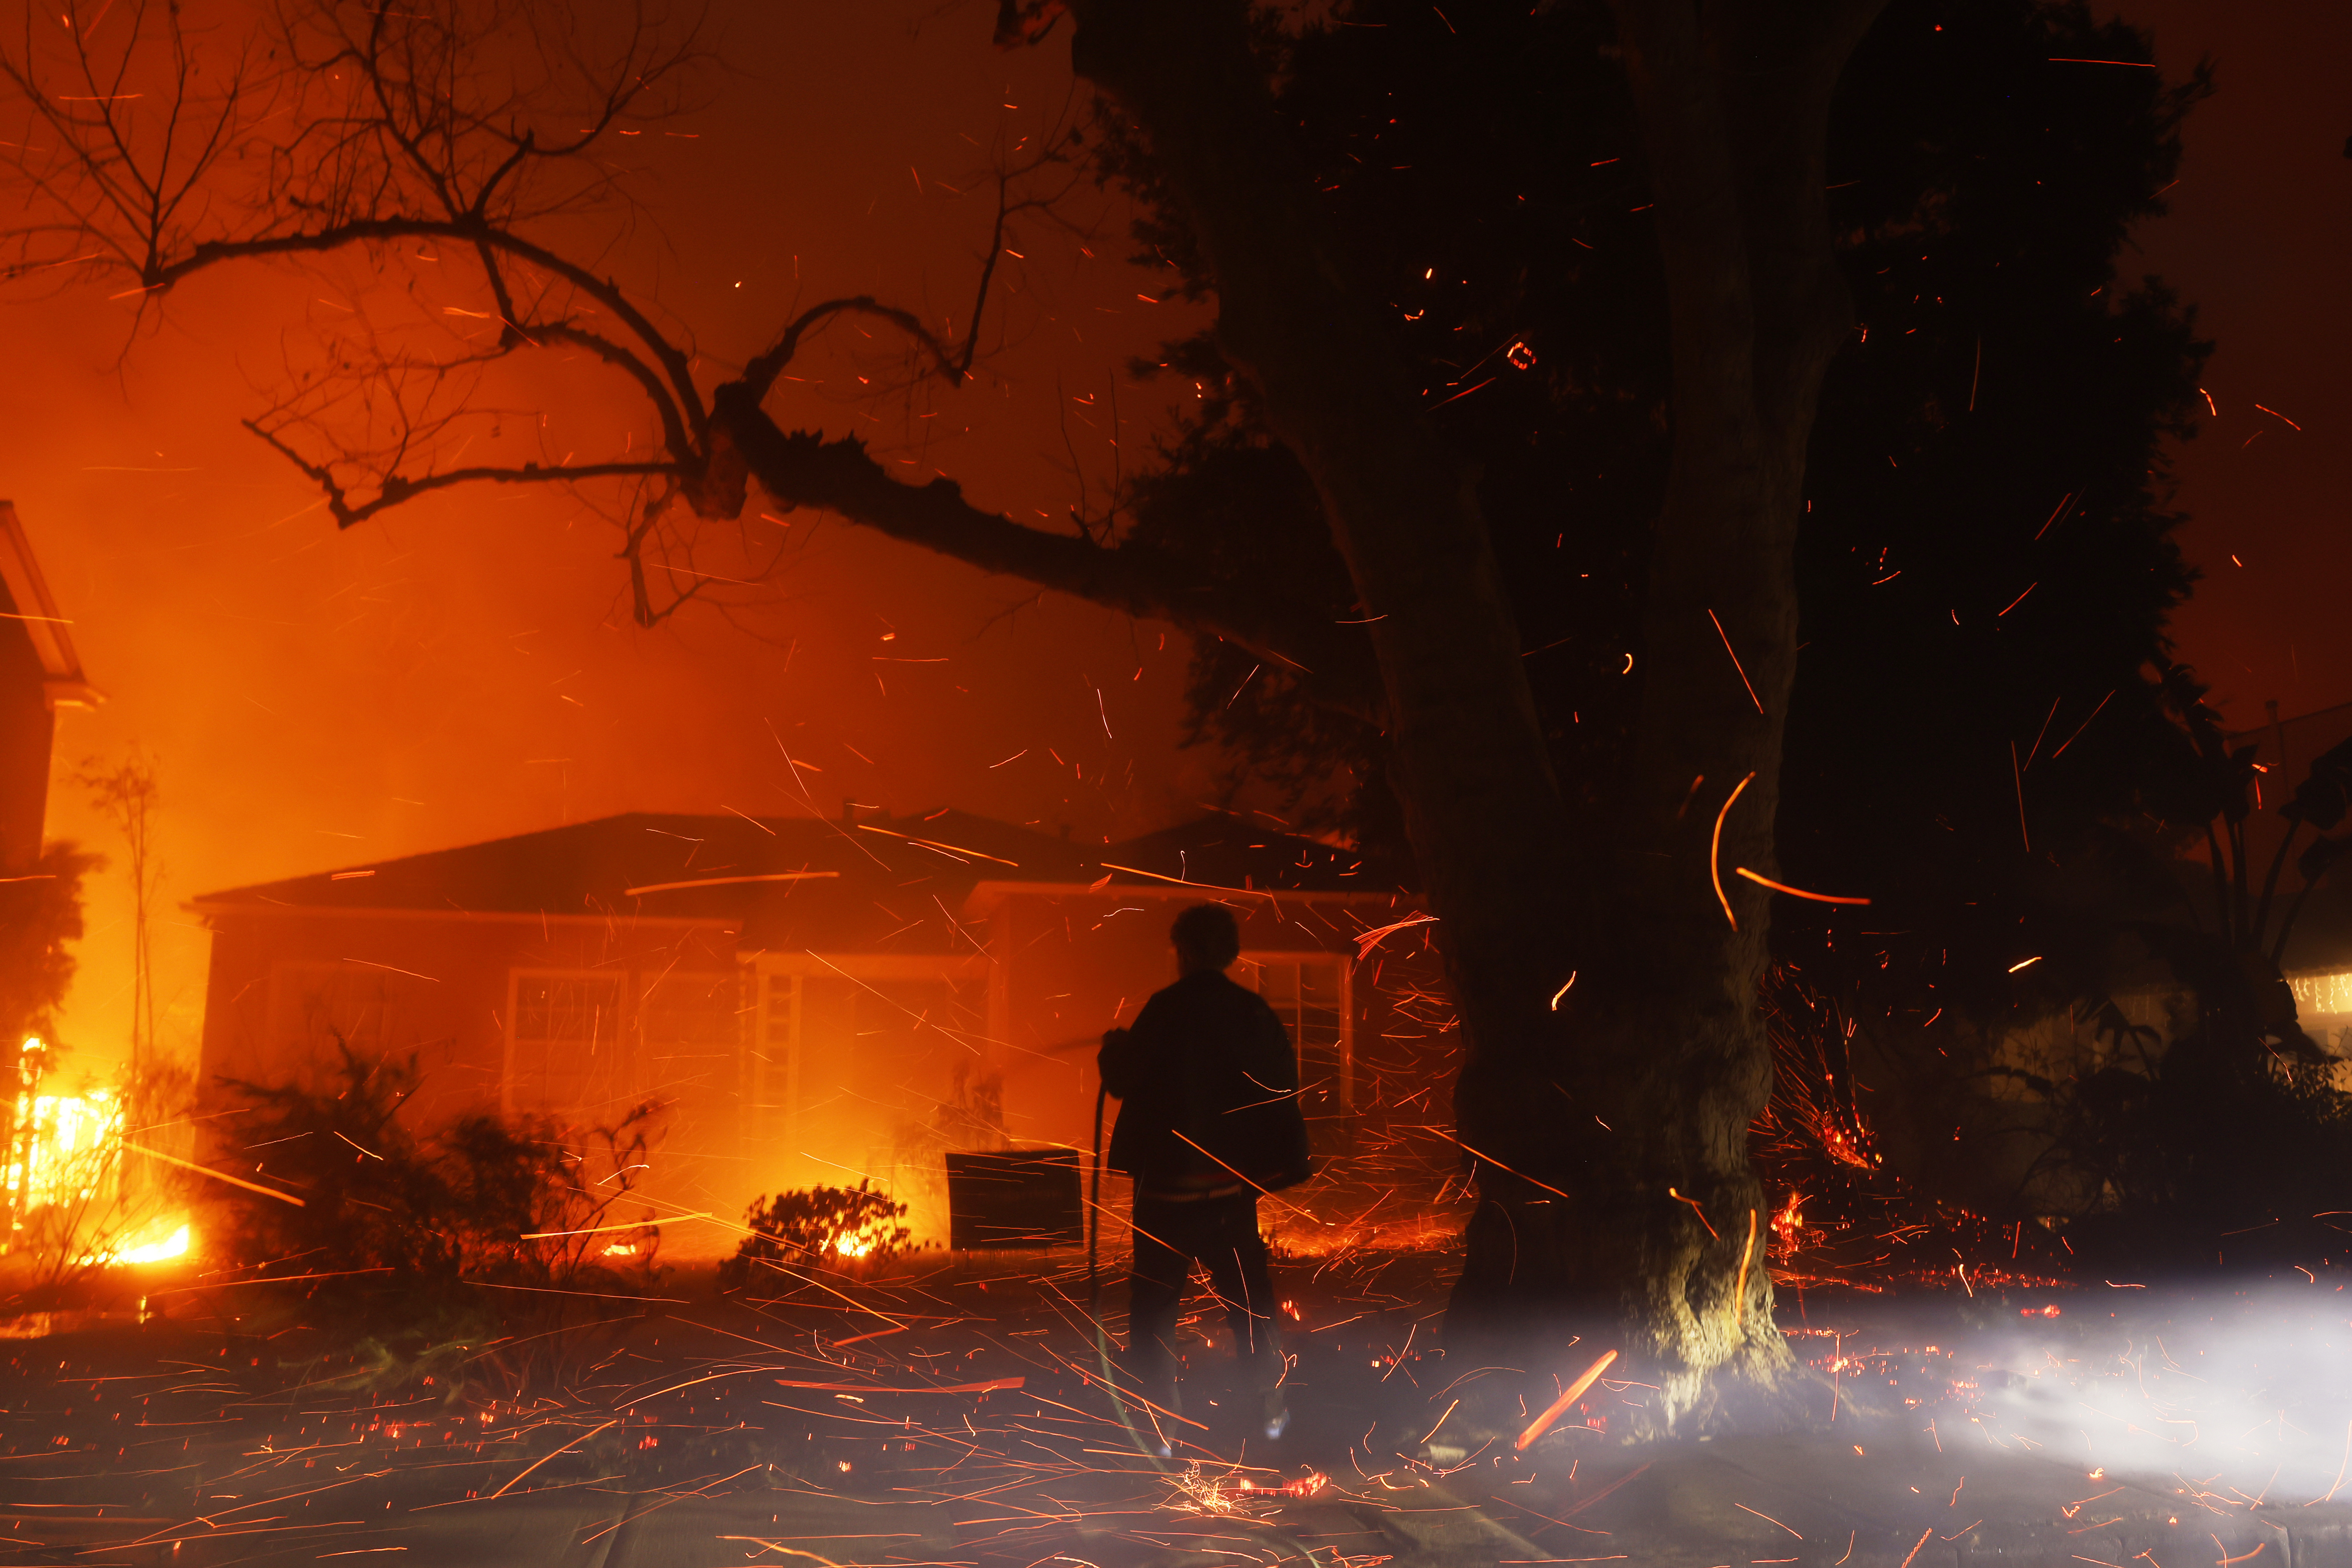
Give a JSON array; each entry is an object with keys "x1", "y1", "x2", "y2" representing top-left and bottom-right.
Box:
[{"x1": 0, "y1": 0, "x2": 2352, "y2": 1081}]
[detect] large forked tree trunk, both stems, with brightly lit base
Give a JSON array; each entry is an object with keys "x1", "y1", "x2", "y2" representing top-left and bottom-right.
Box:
[{"x1": 1049, "y1": 0, "x2": 1870, "y2": 1432}]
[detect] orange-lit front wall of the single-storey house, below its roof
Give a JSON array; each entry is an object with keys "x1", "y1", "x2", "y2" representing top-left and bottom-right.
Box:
[{"x1": 202, "y1": 889, "x2": 1458, "y2": 1255}]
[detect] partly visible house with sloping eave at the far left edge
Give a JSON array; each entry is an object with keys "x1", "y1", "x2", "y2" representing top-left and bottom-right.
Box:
[{"x1": 0, "y1": 501, "x2": 101, "y2": 868}]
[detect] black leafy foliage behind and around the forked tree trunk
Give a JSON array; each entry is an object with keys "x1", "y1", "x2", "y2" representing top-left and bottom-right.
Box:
[{"x1": 1101, "y1": 0, "x2": 2206, "y2": 903}]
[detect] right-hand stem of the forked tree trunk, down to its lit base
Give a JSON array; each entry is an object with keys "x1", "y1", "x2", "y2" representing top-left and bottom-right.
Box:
[{"x1": 1456, "y1": 0, "x2": 1877, "y2": 1429}]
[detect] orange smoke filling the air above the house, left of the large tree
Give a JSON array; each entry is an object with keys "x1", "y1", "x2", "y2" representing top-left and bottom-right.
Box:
[{"x1": 13, "y1": 0, "x2": 1209, "y2": 1069}]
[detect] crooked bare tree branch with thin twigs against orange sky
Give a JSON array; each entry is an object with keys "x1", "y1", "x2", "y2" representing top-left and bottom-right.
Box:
[{"x1": 0, "y1": 0, "x2": 1378, "y2": 715}]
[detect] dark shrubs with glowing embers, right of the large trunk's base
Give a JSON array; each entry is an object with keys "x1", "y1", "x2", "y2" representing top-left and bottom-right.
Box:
[{"x1": 1757, "y1": 665, "x2": 2352, "y2": 1281}]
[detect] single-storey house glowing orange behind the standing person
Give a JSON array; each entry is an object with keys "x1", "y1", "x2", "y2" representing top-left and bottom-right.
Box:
[{"x1": 190, "y1": 809, "x2": 1430, "y2": 1244}]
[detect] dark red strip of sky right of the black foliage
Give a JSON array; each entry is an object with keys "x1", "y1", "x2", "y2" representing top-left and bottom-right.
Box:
[{"x1": 2100, "y1": 0, "x2": 2352, "y2": 726}]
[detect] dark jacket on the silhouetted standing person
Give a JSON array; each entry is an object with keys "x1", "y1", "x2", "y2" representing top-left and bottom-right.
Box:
[{"x1": 1099, "y1": 971, "x2": 1312, "y2": 1194}]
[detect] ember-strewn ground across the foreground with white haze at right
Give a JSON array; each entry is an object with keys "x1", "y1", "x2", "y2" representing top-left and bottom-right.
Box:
[{"x1": 0, "y1": 1251, "x2": 2352, "y2": 1568}]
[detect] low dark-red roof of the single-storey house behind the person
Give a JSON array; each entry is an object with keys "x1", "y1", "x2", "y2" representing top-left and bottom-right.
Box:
[{"x1": 190, "y1": 811, "x2": 1390, "y2": 950}]
